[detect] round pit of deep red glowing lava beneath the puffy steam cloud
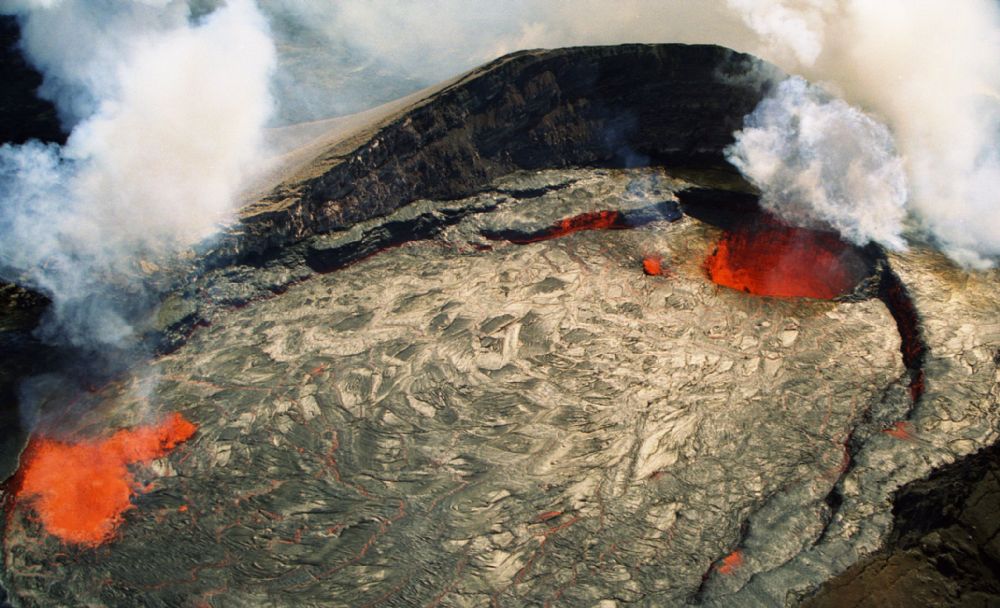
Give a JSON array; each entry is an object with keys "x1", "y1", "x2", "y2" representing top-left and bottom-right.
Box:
[{"x1": 705, "y1": 223, "x2": 863, "y2": 300}]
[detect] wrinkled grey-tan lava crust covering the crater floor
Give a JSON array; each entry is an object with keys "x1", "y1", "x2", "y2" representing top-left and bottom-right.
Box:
[{"x1": 3, "y1": 169, "x2": 1000, "y2": 607}]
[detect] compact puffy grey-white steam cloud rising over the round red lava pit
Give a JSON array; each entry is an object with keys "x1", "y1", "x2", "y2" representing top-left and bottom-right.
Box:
[{"x1": 726, "y1": 77, "x2": 906, "y2": 249}]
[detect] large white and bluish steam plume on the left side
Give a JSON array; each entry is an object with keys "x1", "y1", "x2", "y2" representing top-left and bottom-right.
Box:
[{"x1": 0, "y1": 0, "x2": 275, "y2": 346}]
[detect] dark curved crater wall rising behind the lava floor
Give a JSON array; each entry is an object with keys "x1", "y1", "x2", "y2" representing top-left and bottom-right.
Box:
[{"x1": 223, "y1": 44, "x2": 775, "y2": 265}]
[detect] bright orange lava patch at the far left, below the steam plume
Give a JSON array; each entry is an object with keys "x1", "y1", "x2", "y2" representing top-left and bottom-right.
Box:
[{"x1": 16, "y1": 414, "x2": 197, "y2": 546}]
